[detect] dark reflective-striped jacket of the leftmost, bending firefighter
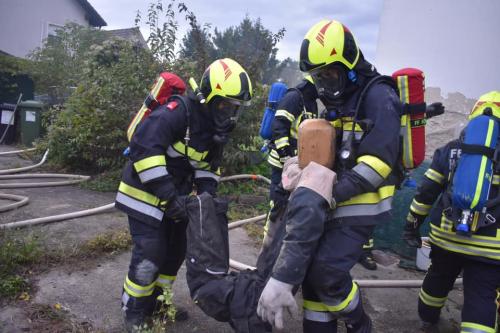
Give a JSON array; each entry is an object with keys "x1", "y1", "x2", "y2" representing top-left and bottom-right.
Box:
[{"x1": 115, "y1": 96, "x2": 222, "y2": 226}]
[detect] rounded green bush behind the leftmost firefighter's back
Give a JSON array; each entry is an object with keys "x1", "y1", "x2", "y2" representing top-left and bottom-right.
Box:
[{"x1": 46, "y1": 39, "x2": 159, "y2": 172}]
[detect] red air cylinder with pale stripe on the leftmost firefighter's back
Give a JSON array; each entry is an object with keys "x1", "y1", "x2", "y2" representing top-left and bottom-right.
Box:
[{"x1": 127, "y1": 72, "x2": 186, "y2": 142}]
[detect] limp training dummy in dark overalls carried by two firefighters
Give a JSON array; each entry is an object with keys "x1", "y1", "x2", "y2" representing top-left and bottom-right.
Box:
[{"x1": 186, "y1": 120, "x2": 336, "y2": 332}]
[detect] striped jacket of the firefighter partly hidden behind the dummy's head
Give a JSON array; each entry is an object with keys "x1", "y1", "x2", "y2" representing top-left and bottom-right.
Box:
[{"x1": 267, "y1": 80, "x2": 318, "y2": 169}]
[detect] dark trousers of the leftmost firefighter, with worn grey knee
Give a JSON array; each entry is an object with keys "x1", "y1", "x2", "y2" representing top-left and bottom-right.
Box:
[{"x1": 122, "y1": 216, "x2": 187, "y2": 324}]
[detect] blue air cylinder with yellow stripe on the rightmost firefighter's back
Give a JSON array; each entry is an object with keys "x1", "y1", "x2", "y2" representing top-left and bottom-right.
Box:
[{"x1": 448, "y1": 115, "x2": 500, "y2": 236}]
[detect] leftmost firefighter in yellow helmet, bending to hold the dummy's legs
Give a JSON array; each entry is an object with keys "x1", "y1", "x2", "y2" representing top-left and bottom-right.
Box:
[{"x1": 115, "y1": 58, "x2": 252, "y2": 331}]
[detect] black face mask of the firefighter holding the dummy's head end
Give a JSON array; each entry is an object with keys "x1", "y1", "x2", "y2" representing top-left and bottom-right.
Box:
[{"x1": 311, "y1": 64, "x2": 346, "y2": 100}]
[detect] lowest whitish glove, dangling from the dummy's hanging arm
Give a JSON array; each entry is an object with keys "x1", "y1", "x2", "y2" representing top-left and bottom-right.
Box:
[{"x1": 257, "y1": 278, "x2": 298, "y2": 330}]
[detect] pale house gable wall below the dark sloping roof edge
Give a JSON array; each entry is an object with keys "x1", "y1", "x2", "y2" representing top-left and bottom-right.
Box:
[{"x1": 0, "y1": 0, "x2": 89, "y2": 57}]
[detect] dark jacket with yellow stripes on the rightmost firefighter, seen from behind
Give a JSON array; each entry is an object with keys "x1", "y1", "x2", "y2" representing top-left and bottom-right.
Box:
[{"x1": 410, "y1": 140, "x2": 500, "y2": 265}]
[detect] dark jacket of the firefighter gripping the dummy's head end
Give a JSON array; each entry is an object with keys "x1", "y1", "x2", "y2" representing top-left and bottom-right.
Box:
[{"x1": 329, "y1": 77, "x2": 402, "y2": 226}]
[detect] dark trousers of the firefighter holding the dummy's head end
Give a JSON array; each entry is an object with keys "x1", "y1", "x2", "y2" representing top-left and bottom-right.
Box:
[{"x1": 302, "y1": 226, "x2": 374, "y2": 333}]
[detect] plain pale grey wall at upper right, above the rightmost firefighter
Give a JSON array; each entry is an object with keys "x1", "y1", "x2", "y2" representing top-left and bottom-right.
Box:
[{"x1": 376, "y1": 0, "x2": 500, "y2": 98}]
